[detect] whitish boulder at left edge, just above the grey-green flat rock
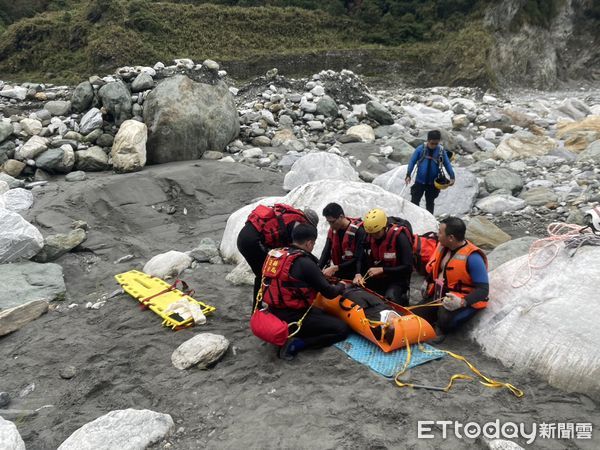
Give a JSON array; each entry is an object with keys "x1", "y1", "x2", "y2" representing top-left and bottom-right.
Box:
[{"x1": 0, "y1": 209, "x2": 44, "y2": 264}]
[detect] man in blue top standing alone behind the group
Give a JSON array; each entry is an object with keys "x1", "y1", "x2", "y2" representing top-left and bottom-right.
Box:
[{"x1": 405, "y1": 130, "x2": 455, "y2": 214}]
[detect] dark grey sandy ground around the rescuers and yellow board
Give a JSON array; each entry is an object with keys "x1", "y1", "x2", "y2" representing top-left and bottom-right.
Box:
[{"x1": 0, "y1": 161, "x2": 600, "y2": 449}]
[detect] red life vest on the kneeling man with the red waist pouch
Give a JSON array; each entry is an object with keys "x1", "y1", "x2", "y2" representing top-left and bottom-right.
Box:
[{"x1": 262, "y1": 247, "x2": 317, "y2": 309}]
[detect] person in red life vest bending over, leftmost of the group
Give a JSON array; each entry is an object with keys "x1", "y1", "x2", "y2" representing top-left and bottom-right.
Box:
[{"x1": 237, "y1": 203, "x2": 319, "y2": 299}]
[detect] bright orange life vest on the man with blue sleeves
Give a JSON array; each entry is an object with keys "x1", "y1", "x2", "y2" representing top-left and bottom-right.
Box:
[{"x1": 427, "y1": 241, "x2": 488, "y2": 309}]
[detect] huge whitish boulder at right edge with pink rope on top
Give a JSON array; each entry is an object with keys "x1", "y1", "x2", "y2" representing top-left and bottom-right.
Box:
[{"x1": 472, "y1": 246, "x2": 600, "y2": 400}]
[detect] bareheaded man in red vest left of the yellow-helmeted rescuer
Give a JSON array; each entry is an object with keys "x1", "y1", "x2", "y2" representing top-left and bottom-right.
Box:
[{"x1": 319, "y1": 203, "x2": 366, "y2": 280}]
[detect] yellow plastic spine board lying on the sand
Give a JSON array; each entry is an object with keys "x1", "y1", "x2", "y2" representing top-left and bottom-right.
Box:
[{"x1": 115, "y1": 270, "x2": 216, "y2": 329}]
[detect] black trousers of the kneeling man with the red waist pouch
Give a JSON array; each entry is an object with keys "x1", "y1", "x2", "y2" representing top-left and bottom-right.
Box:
[{"x1": 269, "y1": 307, "x2": 351, "y2": 348}]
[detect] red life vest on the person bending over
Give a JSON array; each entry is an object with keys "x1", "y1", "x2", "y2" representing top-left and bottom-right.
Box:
[{"x1": 248, "y1": 203, "x2": 308, "y2": 248}]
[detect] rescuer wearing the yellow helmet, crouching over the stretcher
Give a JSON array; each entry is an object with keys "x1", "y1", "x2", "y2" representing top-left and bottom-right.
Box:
[{"x1": 354, "y1": 208, "x2": 413, "y2": 306}]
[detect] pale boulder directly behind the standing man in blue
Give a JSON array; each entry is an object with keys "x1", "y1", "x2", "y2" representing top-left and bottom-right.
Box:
[{"x1": 373, "y1": 165, "x2": 479, "y2": 215}]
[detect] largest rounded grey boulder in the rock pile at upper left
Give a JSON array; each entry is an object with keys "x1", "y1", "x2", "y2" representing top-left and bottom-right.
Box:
[{"x1": 144, "y1": 75, "x2": 240, "y2": 164}]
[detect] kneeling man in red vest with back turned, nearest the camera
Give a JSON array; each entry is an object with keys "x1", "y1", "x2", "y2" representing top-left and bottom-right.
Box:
[{"x1": 263, "y1": 224, "x2": 350, "y2": 360}]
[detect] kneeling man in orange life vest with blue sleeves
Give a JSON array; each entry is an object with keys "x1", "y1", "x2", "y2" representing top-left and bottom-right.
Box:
[{"x1": 415, "y1": 217, "x2": 489, "y2": 335}]
